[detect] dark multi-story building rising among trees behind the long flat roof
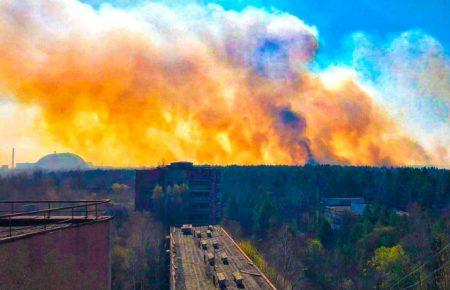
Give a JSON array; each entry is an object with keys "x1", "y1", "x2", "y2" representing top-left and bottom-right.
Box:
[{"x1": 135, "y1": 162, "x2": 221, "y2": 225}]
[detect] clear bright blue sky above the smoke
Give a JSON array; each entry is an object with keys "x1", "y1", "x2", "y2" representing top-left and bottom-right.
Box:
[{"x1": 84, "y1": 0, "x2": 450, "y2": 58}]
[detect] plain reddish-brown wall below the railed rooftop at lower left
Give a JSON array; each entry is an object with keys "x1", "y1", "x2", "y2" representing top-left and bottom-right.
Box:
[{"x1": 0, "y1": 220, "x2": 111, "y2": 290}]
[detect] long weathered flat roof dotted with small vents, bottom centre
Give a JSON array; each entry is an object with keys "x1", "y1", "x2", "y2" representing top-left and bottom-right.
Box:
[{"x1": 170, "y1": 226, "x2": 276, "y2": 290}]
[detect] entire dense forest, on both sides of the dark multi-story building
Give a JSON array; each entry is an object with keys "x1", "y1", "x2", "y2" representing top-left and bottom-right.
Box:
[{"x1": 0, "y1": 165, "x2": 450, "y2": 289}]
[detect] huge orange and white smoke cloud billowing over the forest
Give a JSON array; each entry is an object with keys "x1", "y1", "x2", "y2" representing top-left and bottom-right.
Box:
[{"x1": 0, "y1": 0, "x2": 442, "y2": 165}]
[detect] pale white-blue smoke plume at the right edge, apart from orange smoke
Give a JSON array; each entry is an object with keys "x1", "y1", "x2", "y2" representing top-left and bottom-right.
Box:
[{"x1": 352, "y1": 30, "x2": 450, "y2": 166}]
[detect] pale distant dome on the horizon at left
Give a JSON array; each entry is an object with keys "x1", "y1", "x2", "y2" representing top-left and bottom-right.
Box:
[{"x1": 36, "y1": 153, "x2": 90, "y2": 171}]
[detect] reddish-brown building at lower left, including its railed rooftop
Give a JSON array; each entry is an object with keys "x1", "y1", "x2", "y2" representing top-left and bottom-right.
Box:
[{"x1": 0, "y1": 200, "x2": 111, "y2": 290}]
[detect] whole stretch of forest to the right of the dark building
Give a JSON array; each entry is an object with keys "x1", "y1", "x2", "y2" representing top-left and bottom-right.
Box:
[{"x1": 221, "y1": 166, "x2": 450, "y2": 289}]
